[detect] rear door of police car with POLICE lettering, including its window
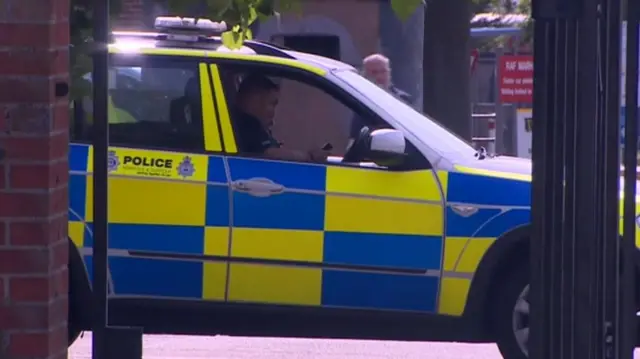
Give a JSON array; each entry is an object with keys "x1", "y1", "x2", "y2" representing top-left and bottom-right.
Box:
[{"x1": 69, "y1": 54, "x2": 229, "y2": 300}]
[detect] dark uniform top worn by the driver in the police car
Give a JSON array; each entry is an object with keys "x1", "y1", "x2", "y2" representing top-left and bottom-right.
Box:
[{"x1": 234, "y1": 110, "x2": 280, "y2": 154}]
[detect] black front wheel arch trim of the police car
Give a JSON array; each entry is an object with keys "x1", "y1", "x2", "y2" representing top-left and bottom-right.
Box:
[{"x1": 463, "y1": 224, "x2": 531, "y2": 330}]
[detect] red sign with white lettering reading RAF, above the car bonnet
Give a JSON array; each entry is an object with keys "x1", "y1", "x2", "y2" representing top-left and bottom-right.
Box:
[{"x1": 498, "y1": 55, "x2": 533, "y2": 104}]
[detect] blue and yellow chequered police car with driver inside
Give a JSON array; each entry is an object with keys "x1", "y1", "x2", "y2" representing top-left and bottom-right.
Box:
[{"x1": 69, "y1": 18, "x2": 640, "y2": 359}]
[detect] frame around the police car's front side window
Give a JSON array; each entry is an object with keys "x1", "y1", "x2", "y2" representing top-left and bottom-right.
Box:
[{"x1": 210, "y1": 58, "x2": 433, "y2": 172}]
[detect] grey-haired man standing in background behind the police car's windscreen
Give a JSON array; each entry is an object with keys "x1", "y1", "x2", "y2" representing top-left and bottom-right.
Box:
[{"x1": 349, "y1": 54, "x2": 413, "y2": 144}]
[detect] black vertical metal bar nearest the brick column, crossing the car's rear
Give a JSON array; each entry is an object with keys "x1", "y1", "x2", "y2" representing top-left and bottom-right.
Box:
[{"x1": 92, "y1": 0, "x2": 109, "y2": 359}]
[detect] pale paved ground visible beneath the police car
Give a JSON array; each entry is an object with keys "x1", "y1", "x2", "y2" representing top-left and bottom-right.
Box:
[{"x1": 70, "y1": 334, "x2": 640, "y2": 359}]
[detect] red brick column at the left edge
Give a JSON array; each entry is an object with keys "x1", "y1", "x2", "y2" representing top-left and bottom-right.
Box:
[{"x1": 0, "y1": 0, "x2": 69, "y2": 359}]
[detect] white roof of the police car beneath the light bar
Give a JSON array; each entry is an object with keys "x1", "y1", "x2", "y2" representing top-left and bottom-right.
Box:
[{"x1": 112, "y1": 31, "x2": 354, "y2": 72}]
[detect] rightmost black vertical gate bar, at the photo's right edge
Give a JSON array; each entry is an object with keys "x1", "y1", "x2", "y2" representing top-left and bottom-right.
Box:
[{"x1": 619, "y1": 0, "x2": 640, "y2": 358}]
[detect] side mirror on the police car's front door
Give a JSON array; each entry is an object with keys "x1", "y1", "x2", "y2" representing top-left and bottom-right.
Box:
[{"x1": 367, "y1": 129, "x2": 407, "y2": 166}]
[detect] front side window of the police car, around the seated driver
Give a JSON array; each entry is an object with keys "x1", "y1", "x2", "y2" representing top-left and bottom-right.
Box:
[{"x1": 220, "y1": 65, "x2": 418, "y2": 169}]
